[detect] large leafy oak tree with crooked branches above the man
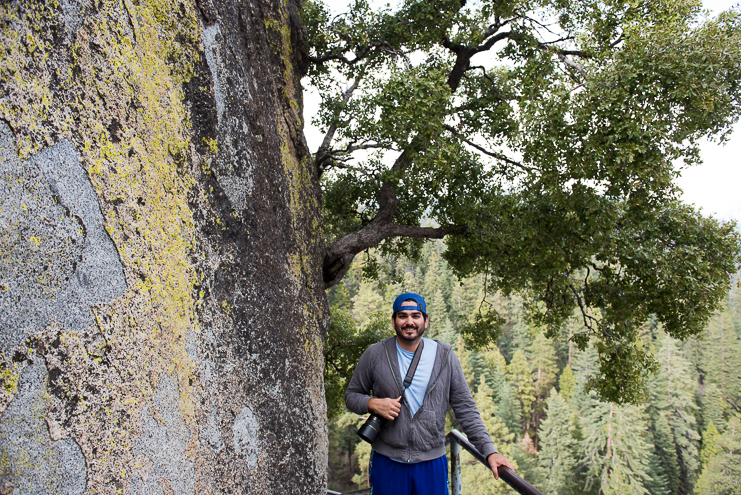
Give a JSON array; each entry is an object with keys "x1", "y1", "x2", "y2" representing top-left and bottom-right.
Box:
[{"x1": 303, "y1": 0, "x2": 741, "y2": 402}]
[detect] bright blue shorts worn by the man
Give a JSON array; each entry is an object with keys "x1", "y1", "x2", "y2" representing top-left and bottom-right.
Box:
[{"x1": 369, "y1": 450, "x2": 450, "y2": 495}]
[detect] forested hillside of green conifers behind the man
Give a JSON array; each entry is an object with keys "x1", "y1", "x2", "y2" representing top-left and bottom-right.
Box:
[{"x1": 325, "y1": 241, "x2": 741, "y2": 495}]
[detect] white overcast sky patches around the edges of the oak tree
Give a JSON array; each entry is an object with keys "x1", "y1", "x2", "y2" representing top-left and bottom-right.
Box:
[{"x1": 304, "y1": 0, "x2": 741, "y2": 223}]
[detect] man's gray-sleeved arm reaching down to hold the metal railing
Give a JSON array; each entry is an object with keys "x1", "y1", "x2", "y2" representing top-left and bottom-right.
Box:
[{"x1": 450, "y1": 350, "x2": 514, "y2": 479}]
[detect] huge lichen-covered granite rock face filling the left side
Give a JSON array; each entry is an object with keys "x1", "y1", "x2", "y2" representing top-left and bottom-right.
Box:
[{"x1": 0, "y1": 0, "x2": 329, "y2": 494}]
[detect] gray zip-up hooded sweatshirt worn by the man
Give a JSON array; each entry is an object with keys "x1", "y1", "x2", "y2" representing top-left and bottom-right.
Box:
[{"x1": 345, "y1": 337, "x2": 497, "y2": 462}]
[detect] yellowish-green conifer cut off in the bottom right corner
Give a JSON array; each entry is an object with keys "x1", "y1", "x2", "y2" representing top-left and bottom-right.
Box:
[{"x1": 695, "y1": 417, "x2": 741, "y2": 495}]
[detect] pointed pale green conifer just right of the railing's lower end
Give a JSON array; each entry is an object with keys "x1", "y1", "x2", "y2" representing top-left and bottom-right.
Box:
[{"x1": 538, "y1": 388, "x2": 578, "y2": 495}]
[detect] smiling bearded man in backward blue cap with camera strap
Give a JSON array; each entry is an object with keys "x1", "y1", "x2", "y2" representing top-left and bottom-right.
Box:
[{"x1": 345, "y1": 293, "x2": 513, "y2": 495}]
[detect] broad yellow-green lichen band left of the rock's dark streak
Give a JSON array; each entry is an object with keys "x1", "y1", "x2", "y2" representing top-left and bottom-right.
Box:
[{"x1": 0, "y1": 0, "x2": 200, "y2": 493}]
